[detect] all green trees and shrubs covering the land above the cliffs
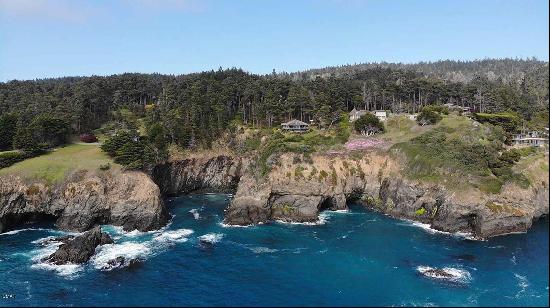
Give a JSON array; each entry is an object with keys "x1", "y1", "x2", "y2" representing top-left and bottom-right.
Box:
[{"x1": 0, "y1": 60, "x2": 548, "y2": 188}]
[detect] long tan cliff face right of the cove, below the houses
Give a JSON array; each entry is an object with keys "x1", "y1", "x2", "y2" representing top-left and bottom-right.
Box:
[{"x1": 225, "y1": 153, "x2": 549, "y2": 238}]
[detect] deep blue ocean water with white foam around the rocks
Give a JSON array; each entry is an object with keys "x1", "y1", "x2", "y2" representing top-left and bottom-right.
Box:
[{"x1": 0, "y1": 194, "x2": 549, "y2": 306}]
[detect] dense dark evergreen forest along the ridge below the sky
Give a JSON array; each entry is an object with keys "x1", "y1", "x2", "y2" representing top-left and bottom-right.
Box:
[{"x1": 0, "y1": 59, "x2": 548, "y2": 147}]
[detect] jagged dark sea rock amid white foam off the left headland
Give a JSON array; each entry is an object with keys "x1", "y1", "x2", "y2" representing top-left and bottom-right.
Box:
[{"x1": 43, "y1": 226, "x2": 113, "y2": 265}]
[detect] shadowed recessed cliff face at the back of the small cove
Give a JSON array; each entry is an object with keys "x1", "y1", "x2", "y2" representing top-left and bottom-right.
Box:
[{"x1": 152, "y1": 156, "x2": 241, "y2": 195}]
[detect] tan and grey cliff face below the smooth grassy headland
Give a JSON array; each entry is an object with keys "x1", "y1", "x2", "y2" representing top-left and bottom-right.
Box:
[{"x1": 0, "y1": 171, "x2": 169, "y2": 232}]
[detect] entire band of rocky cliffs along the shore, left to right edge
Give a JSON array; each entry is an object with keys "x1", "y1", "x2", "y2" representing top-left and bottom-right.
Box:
[{"x1": 0, "y1": 153, "x2": 549, "y2": 238}]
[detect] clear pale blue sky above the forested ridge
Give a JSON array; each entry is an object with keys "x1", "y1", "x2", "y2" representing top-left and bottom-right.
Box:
[{"x1": 0, "y1": 0, "x2": 549, "y2": 81}]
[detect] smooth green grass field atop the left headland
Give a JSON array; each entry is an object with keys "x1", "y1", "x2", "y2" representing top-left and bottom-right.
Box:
[{"x1": 0, "y1": 144, "x2": 116, "y2": 184}]
